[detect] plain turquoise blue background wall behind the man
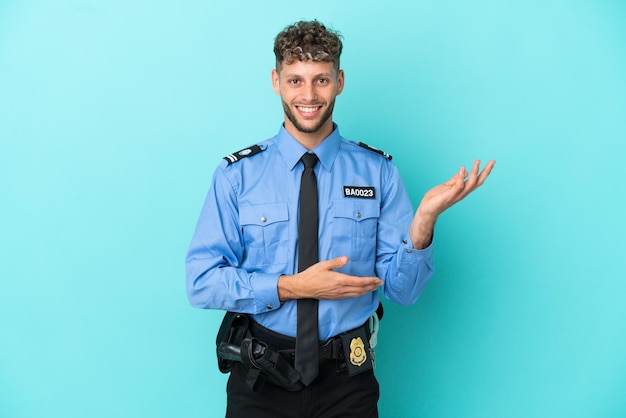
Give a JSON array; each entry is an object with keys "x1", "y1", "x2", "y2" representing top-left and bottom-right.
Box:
[{"x1": 0, "y1": 0, "x2": 626, "y2": 418}]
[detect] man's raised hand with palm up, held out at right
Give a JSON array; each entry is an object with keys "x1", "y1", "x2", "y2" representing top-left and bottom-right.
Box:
[{"x1": 409, "y1": 160, "x2": 496, "y2": 248}]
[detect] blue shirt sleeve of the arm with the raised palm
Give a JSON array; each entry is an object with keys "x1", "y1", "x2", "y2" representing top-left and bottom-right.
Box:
[{"x1": 376, "y1": 163, "x2": 434, "y2": 305}]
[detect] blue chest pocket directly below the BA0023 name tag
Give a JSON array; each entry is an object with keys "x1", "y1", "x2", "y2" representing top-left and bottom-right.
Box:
[{"x1": 332, "y1": 199, "x2": 380, "y2": 263}]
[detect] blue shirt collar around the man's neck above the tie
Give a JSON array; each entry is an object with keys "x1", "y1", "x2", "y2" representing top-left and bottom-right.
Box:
[{"x1": 276, "y1": 123, "x2": 341, "y2": 171}]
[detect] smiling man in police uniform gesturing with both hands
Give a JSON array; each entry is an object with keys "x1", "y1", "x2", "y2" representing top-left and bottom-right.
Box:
[{"x1": 186, "y1": 21, "x2": 495, "y2": 418}]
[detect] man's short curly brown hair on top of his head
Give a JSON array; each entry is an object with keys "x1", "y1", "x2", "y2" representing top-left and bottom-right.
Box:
[{"x1": 274, "y1": 20, "x2": 343, "y2": 71}]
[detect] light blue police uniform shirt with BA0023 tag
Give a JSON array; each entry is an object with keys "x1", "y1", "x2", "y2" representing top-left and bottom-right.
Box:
[{"x1": 186, "y1": 125, "x2": 434, "y2": 340}]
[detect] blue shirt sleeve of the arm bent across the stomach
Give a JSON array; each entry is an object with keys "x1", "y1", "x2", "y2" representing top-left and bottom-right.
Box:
[{"x1": 185, "y1": 164, "x2": 280, "y2": 314}]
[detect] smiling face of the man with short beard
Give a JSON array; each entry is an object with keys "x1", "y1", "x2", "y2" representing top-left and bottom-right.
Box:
[{"x1": 272, "y1": 60, "x2": 344, "y2": 139}]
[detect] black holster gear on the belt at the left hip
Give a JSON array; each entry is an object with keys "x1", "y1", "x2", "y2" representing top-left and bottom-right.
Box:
[{"x1": 216, "y1": 312, "x2": 303, "y2": 391}]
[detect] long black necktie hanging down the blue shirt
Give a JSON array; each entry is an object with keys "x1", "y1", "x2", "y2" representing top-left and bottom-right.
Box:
[{"x1": 295, "y1": 153, "x2": 319, "y2": 386}]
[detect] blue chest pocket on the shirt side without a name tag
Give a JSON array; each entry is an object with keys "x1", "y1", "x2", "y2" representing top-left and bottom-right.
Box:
[{"x1": 239, "y1": 203, "x2": 289, "y2": 266}]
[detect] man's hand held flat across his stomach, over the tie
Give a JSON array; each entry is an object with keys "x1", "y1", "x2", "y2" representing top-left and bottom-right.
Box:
[{"x1": 278, "y1": 256, "x2": 384, "y2": 301}]
